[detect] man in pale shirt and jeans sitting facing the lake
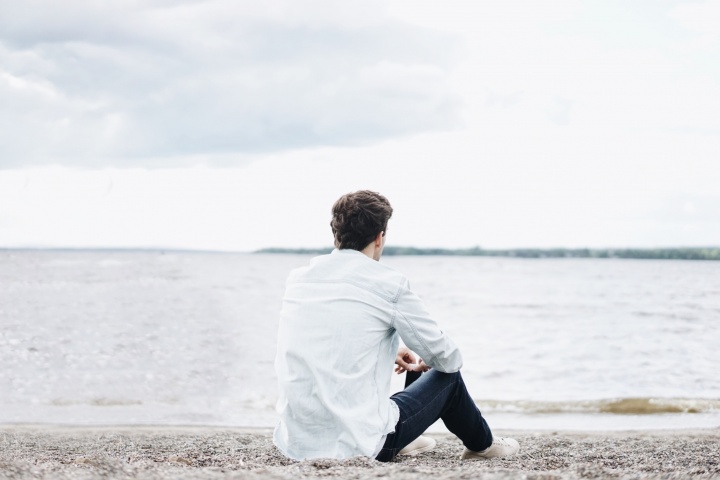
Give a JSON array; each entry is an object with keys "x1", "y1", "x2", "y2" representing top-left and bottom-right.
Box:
[{"x1": 274, "y1": 190, "x2": 519, "y2": 462}]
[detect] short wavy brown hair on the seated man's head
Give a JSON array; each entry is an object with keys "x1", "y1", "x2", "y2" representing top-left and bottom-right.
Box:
[{"x1": 330, "y1": 190, "x2": 392, "y2": 250}]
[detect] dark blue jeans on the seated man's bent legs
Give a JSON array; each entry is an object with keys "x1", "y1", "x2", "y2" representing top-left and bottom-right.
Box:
[{"x1": 376, "y1": 369, "x2": 493, "y2": 462}]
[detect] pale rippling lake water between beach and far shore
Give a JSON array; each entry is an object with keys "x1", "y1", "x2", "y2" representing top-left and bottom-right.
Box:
[{"x1": 0, "y1": 251, "x2": 720, "y2": 430}]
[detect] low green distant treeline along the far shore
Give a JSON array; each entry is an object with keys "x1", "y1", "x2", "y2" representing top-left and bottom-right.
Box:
[{"x1": 255, "y1": 246, "x2": 720, "y2": 260}]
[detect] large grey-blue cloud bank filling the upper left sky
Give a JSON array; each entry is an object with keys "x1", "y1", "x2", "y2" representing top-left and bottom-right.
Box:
[{"x1": 0, "y1": 0, "x2": 459, "y2": 168}]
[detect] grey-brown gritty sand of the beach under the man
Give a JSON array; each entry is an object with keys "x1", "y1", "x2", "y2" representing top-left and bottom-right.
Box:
[{"x1": 0, "y1": 425, "x2": 720, "y2": 480}]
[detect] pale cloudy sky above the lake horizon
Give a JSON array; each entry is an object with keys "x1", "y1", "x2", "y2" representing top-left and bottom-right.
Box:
[{"x1": 0, "y1": 0, "x2": 720, "y2": 251}]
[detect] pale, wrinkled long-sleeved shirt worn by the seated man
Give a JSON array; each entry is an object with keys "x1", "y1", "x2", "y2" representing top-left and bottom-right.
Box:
[{"x1": 273, "y1": 250, "x2": 462, "y2": 460}]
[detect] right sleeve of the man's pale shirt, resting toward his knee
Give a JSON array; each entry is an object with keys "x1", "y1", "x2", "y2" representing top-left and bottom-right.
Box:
[{"x1": 393, "y1": 283, "x2": 462, "y2": 373}]
